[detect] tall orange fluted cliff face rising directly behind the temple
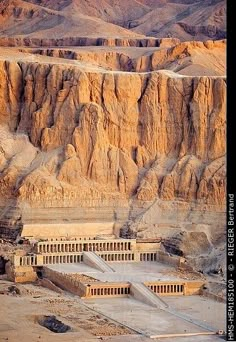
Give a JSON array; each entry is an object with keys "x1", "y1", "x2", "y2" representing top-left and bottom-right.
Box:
[{"x1": 0, "y1": 57, "x2": 226, "y2": 210}]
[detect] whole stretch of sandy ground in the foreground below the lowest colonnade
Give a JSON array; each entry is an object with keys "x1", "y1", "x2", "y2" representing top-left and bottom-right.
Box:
[{"x1": 0, "y1": 272, "x2": 225, "y2": 342}]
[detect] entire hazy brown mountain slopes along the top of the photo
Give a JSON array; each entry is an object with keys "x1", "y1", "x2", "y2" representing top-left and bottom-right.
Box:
[{"x1": 0, "y1": 0, "x2": 226, "y2": 40}]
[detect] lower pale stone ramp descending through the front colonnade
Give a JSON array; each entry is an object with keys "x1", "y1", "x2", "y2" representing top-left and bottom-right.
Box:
[{"x1": 130, "y1": 283, "x2": 168, "y2": 309}]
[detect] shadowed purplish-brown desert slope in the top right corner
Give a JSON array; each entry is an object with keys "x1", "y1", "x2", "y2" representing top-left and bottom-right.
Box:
[{"x1": 129, "y1": 0, "x2": 226, "y2": 40}]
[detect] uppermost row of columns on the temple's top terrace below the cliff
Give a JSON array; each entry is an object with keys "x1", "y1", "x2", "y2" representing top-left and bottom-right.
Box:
[{"x1": 37, "y1": 242, "x2": 131, "y2": 253}]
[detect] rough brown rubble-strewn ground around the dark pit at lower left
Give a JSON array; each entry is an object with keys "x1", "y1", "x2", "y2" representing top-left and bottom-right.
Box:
[{"x1": 0, "y1": 280, "x2": 135, "y2": 342}]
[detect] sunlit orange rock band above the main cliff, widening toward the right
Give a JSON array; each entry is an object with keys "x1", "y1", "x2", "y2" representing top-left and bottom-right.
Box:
[{"x1": 16, "y1": 38, "x2": 226, "y2": 76}]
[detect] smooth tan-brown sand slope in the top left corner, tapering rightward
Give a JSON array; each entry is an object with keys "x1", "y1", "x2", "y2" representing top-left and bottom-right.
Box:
[{"x1": 0, "y1": 0, "x2": 143, "y2": 38}]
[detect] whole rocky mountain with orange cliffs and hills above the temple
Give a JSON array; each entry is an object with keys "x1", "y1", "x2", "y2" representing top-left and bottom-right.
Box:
[{"x1": 0, "y1": 0, "x2": 226, "y2": 271}]
